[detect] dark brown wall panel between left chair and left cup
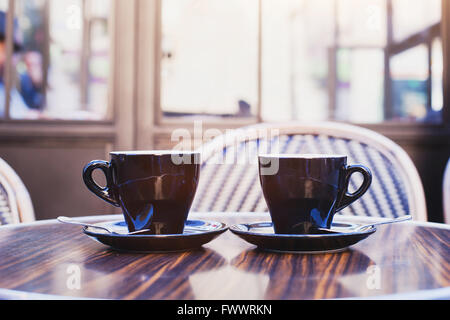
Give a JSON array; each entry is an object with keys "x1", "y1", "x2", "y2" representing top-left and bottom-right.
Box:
[{"x1": 0, "y1": 143, "x2": 119, "y2": 220}]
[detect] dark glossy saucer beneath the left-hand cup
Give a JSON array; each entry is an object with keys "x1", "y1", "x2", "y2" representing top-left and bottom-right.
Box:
[{"x1": 83, "y1": 220, "x2": 228, "y2": 252}]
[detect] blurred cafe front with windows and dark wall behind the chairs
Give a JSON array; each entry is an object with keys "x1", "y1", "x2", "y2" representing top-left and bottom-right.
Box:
[{"x1": 0, "y1": 0, "x2": 450, "y2": 222}]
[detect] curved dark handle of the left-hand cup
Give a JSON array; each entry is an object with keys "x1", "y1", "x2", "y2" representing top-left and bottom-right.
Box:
[{"x1": 83, "y1": 160, "x2": 120, "y2": 207}]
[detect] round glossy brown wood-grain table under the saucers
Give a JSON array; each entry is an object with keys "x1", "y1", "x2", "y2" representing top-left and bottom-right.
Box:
[{"x1": 0, "y1": 213, "x2": 450, "y2": 300}]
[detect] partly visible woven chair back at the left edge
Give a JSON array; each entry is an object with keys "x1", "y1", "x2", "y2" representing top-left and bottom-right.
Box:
[{"x1": 0, "y1": 158, "x2": 35, "y2": 225}]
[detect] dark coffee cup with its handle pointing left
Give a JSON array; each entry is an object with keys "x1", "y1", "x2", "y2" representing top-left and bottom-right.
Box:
[{"x1": 83, "y1": 151, "x2": 200, "y2": 235}]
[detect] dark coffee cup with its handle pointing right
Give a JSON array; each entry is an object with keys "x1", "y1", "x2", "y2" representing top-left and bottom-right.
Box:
[{"x1": 259, "y1": 154, "x2": 372, "y2": 234}]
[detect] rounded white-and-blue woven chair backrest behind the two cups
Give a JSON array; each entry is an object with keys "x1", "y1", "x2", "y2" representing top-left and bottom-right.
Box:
[{"x1": 192, "y1": 122, "x2": 427, "y2": 221}]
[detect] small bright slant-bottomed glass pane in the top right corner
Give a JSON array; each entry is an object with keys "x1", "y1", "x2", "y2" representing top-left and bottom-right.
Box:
[{"x1": 392, "y1": 0, "x2": 442, "y2": 41}]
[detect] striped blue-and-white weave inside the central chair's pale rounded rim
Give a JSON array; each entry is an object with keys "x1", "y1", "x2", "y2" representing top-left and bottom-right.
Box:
[{"x1": 192, "y1": 134, "x2": 409, "y2": 218}]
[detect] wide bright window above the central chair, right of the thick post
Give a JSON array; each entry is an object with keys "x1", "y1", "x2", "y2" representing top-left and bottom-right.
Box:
[{"x1": 160, "y1": 0, "x2": 443, "y2": 124}]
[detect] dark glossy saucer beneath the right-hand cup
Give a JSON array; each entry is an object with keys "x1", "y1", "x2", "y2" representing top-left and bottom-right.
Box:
[{"x1": 230, "y1": 222, "x2": 377, "y2": 253}]
